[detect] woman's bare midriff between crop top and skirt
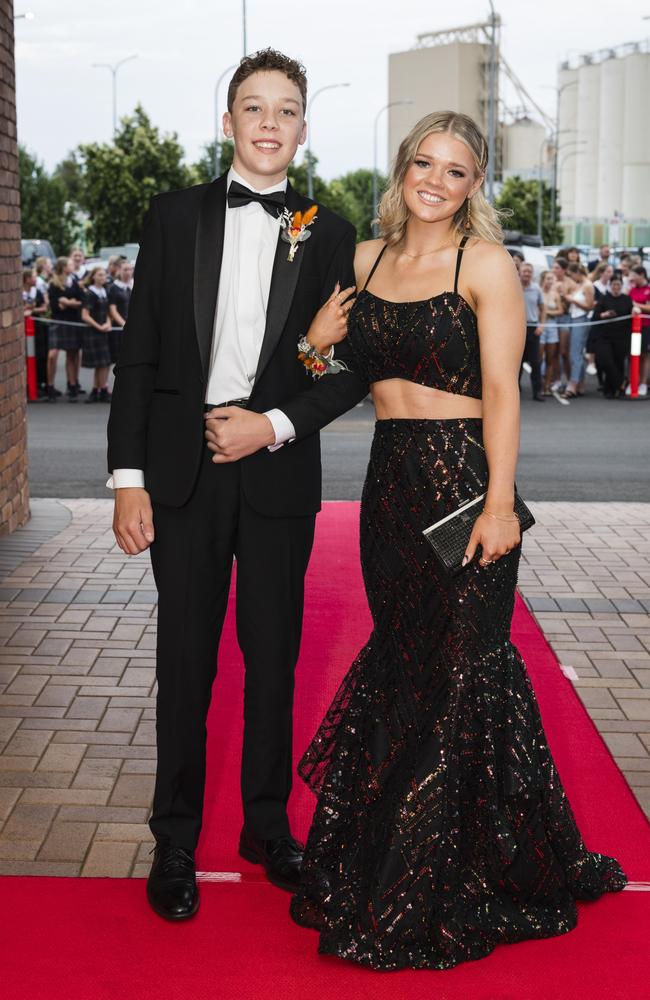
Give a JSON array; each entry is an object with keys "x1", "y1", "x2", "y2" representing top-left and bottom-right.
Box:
[{"x1": 370, "y1": 378, "x2": 483, "y2": 420}]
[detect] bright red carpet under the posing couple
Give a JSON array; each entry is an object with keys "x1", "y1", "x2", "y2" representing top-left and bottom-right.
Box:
[{"x1": 0, "y1": 503, "x2": 650, "y2": 1000}]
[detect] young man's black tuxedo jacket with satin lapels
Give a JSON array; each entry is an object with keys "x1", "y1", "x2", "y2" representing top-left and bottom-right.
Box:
[{"x1": 108, "y1": 175, "x2": 368, "y2": 517}]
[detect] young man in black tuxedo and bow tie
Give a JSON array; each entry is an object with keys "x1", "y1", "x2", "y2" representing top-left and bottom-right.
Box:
[{"x1": 108, "y1": 50, "x2": 367, "y2": 920}]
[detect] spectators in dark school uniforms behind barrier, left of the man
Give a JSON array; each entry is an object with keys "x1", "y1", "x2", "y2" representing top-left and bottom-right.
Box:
[{"x1": 23, "y1": 247, "x2": 133, "y2": 403}]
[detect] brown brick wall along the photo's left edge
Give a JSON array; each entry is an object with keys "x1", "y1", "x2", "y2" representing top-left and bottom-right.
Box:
[{"x1": 0, "y1": 0, "x2": 29, "y2": 535}]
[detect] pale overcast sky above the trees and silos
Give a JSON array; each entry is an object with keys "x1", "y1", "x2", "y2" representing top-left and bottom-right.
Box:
[{"x1": 15, "y1": 0, "x2": 650, "y2": 179}]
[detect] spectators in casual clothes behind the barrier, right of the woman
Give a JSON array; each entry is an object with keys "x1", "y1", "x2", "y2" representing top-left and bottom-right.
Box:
[{"x1": 513, "y1": 246, "x2": 650, "y2": 406}]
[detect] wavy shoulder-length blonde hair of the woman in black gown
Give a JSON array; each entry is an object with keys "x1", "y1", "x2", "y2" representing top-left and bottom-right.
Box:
[{"x1": 379, "y1": 111, "x2": 503, "y2": 246}]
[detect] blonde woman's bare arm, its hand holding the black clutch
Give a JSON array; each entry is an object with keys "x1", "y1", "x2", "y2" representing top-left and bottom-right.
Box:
[{"x1": 466, "y1": 243, "x2": 526, "y2": 561}]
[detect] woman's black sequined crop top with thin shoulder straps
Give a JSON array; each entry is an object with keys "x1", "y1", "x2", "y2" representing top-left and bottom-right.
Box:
[{"x1": 348, "y1": 237, "x2": 481, "y2": 399}]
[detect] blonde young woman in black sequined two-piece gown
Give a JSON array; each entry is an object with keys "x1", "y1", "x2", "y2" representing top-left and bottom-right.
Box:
[{"x1": 291, "y1": 112, "x2": 626, "y2": 969}]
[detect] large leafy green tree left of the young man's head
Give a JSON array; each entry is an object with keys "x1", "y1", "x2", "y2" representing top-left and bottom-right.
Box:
[{"x1": 78, "y1": 105, "x2": 194, "y2": 248}]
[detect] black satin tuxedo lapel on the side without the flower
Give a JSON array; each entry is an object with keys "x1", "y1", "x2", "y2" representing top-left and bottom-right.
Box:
[{"x1": 194, "y1": 174, "x2": 227, "y2": 379}]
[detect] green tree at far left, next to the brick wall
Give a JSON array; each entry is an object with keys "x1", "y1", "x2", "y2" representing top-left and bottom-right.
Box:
[{"x1": 18, "y1": 146, "x2": 77, "y2": 254}]
